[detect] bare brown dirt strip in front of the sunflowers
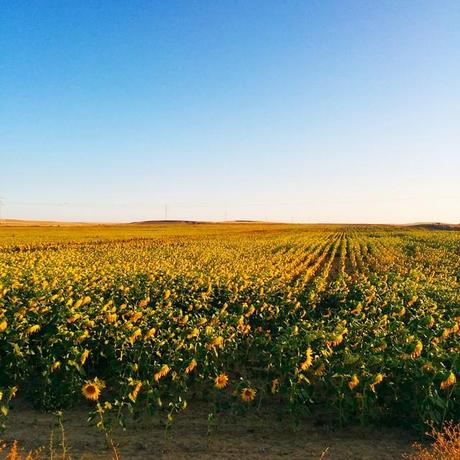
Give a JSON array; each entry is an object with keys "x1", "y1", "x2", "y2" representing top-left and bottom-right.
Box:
[{"x1": 1, "y1": 402, "x2": 416, "y2": 460}]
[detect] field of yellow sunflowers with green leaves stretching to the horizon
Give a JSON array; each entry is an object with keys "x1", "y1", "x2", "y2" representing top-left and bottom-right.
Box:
[{"x1": 0, "y1": 224, "x2": 460, "y2": 432}]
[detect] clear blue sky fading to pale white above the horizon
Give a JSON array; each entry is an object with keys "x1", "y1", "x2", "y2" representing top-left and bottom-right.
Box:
[{"x1": 0, "y1": 0, "x2": 460, "y2": 222}]
